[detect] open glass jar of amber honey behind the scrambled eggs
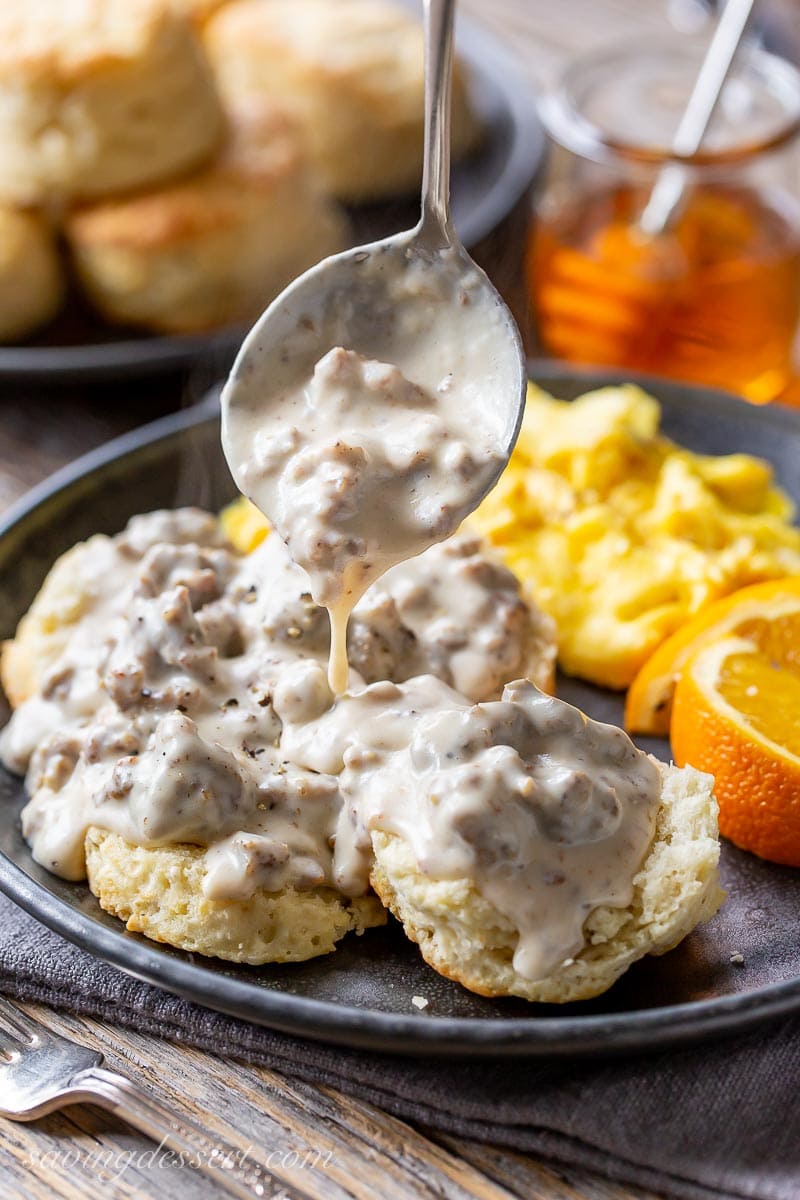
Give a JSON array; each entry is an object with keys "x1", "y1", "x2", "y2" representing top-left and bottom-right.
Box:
[{"x1": 527, "y1": 42, "x2": 800, "y2": 403}]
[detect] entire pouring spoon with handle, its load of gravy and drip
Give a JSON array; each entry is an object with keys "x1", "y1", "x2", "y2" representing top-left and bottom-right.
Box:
[{"x1": 222, "y1": 0, "x2": 527, "y2": 695}]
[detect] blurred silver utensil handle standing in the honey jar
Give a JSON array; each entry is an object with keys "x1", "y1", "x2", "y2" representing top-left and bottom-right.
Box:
[{"x1": 638, "y1": 0, "x2": 756, "y2": 238}]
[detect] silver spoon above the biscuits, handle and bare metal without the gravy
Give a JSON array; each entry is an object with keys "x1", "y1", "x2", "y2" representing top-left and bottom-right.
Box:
[{"x1": 222, "y1": 0, "x2": 527, "y2": 516}]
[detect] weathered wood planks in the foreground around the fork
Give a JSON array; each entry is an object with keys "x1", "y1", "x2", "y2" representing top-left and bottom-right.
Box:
[{"x1": 0, "y1": 1006, "x2": 656, "y2": 1200}]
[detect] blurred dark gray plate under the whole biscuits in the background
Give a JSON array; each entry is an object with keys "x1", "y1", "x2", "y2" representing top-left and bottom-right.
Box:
[{"x1": 0, "y1": 20, "x2": 545, "y2": 386}]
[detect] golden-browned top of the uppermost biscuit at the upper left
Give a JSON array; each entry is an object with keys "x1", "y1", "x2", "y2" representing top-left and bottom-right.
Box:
[{"x1": 0, "y1": 0, "x2": 185, "y2": 84}]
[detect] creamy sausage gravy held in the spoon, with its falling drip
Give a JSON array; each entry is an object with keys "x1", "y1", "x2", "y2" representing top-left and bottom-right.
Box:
[{"x1": 222, "y1": 252, "x2": 507, "y2": 694}]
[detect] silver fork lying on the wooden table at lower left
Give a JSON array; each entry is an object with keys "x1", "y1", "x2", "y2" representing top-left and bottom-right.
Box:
[{"x1": 0, "y1": 996, "x2": 308, "y2": 1200}]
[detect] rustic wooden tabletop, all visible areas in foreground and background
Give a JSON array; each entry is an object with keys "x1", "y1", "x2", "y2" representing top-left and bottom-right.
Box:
[{"x1": 0, "y1": 0, "x2": 781, "y2": 1200}]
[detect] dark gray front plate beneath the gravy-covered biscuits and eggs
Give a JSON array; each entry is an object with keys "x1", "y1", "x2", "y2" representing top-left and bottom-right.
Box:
[{"x1": 0, "y1": 366, "x2": 800, "y2": 1056}]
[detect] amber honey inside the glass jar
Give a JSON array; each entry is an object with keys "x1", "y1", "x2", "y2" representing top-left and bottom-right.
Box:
[{"x1": 528, "y1": 181, "x2": 800, "y2": 403}]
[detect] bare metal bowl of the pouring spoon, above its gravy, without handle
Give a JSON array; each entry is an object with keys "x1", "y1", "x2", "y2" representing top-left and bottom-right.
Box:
[{"x1": 223, "y1": 227, "x2": 527, "y2": 505}]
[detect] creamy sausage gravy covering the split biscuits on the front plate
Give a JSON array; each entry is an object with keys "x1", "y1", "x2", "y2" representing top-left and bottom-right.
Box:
[{"x1": 0, "y1": 510, "x2": 660, "y2": 978}]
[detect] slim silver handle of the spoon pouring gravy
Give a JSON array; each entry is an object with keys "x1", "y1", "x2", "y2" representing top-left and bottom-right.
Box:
[{"x1": 419, "y1": 0, "x2": 456, "y2": 246}]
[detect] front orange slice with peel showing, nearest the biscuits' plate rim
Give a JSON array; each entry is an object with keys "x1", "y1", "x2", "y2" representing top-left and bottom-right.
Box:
[{"x1": 670, "y1": 637, "x2": 800, "y2": 866}]
